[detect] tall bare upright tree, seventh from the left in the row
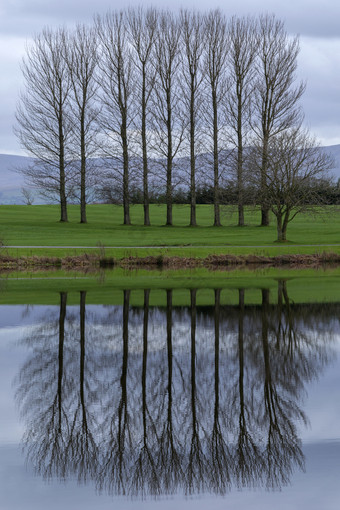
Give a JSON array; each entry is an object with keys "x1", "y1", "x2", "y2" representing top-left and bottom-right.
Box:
[{"x1": 204, "y1": 10, "x2": 228, "y2": 227}]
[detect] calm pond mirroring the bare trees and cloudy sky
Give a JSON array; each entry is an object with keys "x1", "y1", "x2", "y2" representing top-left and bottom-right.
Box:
[{"x1": 0, "y1": 272, "x2": 340, "y2": 510}]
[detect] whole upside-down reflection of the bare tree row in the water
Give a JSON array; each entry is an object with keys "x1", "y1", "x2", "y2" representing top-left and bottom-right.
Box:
[{"x1": 16, "y1": 281, "x2": 335, "y2": 496}]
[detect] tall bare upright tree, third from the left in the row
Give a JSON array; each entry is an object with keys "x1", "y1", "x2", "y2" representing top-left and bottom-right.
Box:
[{"x1": 96, "y1": 11, "x2": 134, "y2": 225}]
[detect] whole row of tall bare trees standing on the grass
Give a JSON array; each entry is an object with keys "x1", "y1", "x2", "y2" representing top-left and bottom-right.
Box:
[{"x1": 15, "y1": 8, "x2": 331, "y2": 238}]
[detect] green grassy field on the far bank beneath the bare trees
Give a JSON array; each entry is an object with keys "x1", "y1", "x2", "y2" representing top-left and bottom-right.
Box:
[{"x1": 0, "y1": 205, "x2": 340, "y2": 258}]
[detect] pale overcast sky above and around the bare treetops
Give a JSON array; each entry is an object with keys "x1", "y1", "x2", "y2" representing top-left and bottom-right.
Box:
[{"x1": 0, "y1": 0, "x2": 340, "y2": 154}]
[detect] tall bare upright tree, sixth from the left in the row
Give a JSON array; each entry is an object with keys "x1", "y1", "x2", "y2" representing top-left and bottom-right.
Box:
[{"x1": 181, "y1": 10, "x2": 204, "y2": 226}]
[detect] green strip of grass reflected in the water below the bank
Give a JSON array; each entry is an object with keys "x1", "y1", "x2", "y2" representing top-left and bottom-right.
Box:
[{"x1": 0, "y1": 268, "x2": 340, "y2": 306}]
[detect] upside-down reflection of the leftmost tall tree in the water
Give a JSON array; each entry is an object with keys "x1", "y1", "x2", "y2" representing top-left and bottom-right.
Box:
[{"x1": 16, "y1": 292, "x2": 70, "y2": 478}]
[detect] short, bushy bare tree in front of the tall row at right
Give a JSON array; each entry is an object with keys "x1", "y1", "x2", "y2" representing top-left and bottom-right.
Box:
[{"x1": 254, "y1": 126, "x2": 334, "y2": 241}]
